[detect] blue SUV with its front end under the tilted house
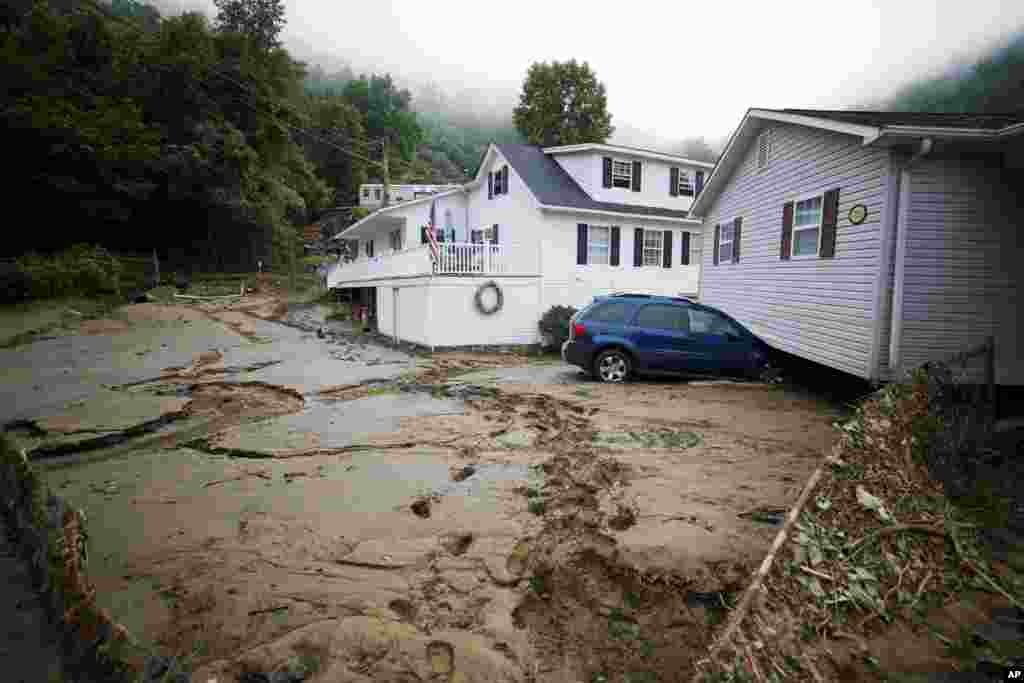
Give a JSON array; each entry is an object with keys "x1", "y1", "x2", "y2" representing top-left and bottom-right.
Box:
[{"x1": 562, "y1": 294, "x2": 770, "y2": 382}]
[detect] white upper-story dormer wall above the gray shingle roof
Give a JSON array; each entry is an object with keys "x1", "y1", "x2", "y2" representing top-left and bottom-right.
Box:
[{"x1": 554, "y1": 153, "x2": 711, "y2": 211}]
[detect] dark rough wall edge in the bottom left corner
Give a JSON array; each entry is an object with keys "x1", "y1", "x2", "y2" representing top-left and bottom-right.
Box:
[{"x1": 0, "y1": 435, "x2": 191, "y2": 683}]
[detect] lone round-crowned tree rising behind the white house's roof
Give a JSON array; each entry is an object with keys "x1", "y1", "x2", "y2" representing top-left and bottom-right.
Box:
[{"x1": 513, "y1": 59, "x2": 614, "y2": 146}]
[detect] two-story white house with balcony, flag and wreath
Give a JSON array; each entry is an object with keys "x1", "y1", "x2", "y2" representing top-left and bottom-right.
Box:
[{"x1": 328, "y1": 144, "x2": 713, "y2": 347}]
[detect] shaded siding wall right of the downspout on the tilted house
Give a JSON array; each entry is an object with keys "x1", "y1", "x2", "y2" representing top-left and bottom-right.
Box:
[{"x1": 895, "y1": 155, "x2": 1024, "y2": 384}]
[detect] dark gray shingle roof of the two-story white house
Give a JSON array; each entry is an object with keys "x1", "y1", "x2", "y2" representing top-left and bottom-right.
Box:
[{"x1": 497, "y1": 143, "x2": 688, "y2": 218}]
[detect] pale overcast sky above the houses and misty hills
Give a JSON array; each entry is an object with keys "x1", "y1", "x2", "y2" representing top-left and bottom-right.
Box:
[{"x1": 155, "y1": 0, "x2": 1024, "y2": 140}]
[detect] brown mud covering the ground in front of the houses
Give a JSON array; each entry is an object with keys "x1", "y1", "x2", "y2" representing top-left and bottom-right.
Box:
[{"x1": 0, "y1": 297, "x2": 837, "y2": 683}]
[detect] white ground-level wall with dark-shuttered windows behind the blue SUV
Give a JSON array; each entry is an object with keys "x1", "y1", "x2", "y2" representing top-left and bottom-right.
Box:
[{"x1": 542, "y1": 212, "x2": 701, "y2": 309}]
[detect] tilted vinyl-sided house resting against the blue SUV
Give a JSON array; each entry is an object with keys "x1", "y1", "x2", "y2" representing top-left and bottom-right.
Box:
[{"x1": 691, "y1": 109, "x2": 1024, "y2": 384}]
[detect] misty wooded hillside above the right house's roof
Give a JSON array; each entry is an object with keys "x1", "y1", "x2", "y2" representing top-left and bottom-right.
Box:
[{"x1": 884, "y1": 33, "x2": 1024, "y2": 114}]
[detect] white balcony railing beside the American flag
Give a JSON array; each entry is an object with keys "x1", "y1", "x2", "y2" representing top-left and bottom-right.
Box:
[{"x1": 328, "y1": 242, "x2": 536, "y2": 287}]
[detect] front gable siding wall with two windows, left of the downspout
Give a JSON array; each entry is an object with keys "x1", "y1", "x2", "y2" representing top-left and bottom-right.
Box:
[{"x1": 700, "y1": 125, "x2": 889, "y2": 378}]
